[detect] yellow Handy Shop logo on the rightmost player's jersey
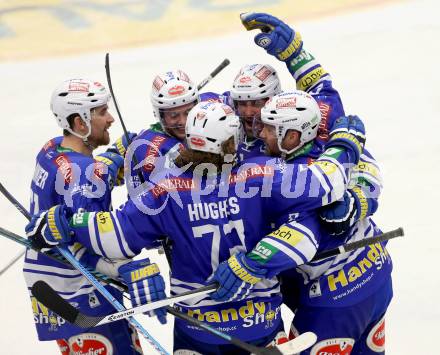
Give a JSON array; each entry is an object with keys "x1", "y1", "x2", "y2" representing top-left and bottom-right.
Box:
[{"x1": 327, "y1": 243, "x2": 390, "y2": 292}]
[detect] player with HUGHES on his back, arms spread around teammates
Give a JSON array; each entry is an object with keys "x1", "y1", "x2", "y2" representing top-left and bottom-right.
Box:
[{"x1": 25, "y1": 93, "x2": 363, "y2": 354}]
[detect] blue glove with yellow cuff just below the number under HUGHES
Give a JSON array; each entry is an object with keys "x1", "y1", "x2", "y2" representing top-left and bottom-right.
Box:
[{"x1": 208, "y1": 252, "x2": 266, "y2": 302}]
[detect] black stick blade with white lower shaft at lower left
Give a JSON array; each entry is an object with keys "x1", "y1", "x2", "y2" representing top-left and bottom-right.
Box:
[{"x1": 32, "y1": 281, "x2": 217, "y2": 328}]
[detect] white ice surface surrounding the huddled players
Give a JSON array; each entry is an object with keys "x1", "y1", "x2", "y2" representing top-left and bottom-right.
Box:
[{"x1": 0, "y1": 0, "x2": 440, "y2": 355}]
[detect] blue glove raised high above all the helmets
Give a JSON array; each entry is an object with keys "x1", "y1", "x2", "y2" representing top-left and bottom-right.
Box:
[{"x1": 240, "y1": 12, "x2": 303, "y2": 62}]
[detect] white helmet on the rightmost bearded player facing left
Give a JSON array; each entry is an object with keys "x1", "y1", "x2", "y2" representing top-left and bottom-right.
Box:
[{"x1": 261, "y1": 90, "x2": 321, "y2": 154}]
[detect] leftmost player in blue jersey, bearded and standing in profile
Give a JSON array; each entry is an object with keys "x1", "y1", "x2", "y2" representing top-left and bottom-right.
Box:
[{"x1": 23, "y1": 79, "x2": 142, "y2": 355}]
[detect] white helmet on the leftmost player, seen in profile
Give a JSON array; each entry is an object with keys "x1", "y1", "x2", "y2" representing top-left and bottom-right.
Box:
[{"x1": 50, "y1": 79, "x2": 110, "y2": 139}]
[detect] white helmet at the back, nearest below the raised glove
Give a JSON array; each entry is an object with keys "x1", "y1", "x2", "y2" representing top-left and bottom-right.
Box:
[{"x1": 231, "y1": 64, "x2": 281, "y2": 101}]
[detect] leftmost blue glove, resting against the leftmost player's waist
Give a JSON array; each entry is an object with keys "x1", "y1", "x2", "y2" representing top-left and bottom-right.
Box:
[{"x1": 25, "y1": 205, "x2": 71, "y2": 251}]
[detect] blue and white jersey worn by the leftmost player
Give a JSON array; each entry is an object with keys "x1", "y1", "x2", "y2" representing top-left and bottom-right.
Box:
[{"x1": 23, "y1": 137, "x2": 122, "y2": 340}]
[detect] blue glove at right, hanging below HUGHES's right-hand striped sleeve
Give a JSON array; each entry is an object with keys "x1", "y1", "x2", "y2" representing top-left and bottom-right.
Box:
[{"x1": 319, "y1": 186, "x2": 378, "y2": 235}]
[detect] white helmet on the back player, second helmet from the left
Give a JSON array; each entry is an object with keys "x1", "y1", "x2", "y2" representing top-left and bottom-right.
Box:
[{"x1": 150, "y1": 70, "x2": 199, "y2": 124}]
